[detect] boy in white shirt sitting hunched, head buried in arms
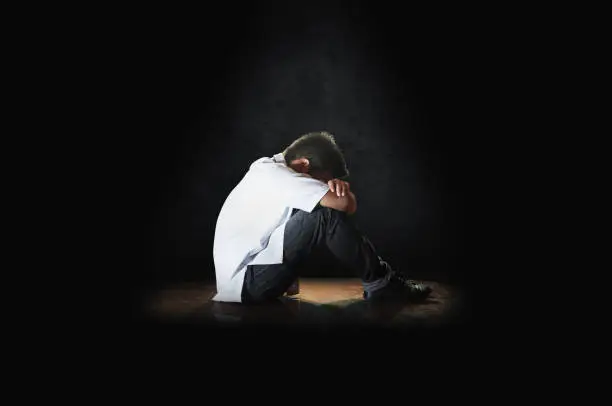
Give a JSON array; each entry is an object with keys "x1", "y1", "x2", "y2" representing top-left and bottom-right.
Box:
[{"x1": 213, "y1": 132, "x2": 431, "y2": 303}]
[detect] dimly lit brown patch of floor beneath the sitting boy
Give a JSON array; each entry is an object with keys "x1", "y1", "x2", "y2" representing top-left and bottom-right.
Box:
[{"x1": 143, "y1": 278, "x2": 461, "y2": 325}]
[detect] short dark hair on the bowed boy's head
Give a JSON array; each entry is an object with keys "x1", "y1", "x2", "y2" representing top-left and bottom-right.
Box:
[{"x1": 283, "y1": 131, "x2": 349, "y2": 178}]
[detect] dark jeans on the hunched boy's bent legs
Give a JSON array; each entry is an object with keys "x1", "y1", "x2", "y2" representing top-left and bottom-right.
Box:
[{"x1": 243, "y1": 206, "x2": 391, "y2": 302}]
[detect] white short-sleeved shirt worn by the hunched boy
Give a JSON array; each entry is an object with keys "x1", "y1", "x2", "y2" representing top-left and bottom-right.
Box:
[{"x1": 213, "y1": 154, "x2": 329, "y2": 302}]
